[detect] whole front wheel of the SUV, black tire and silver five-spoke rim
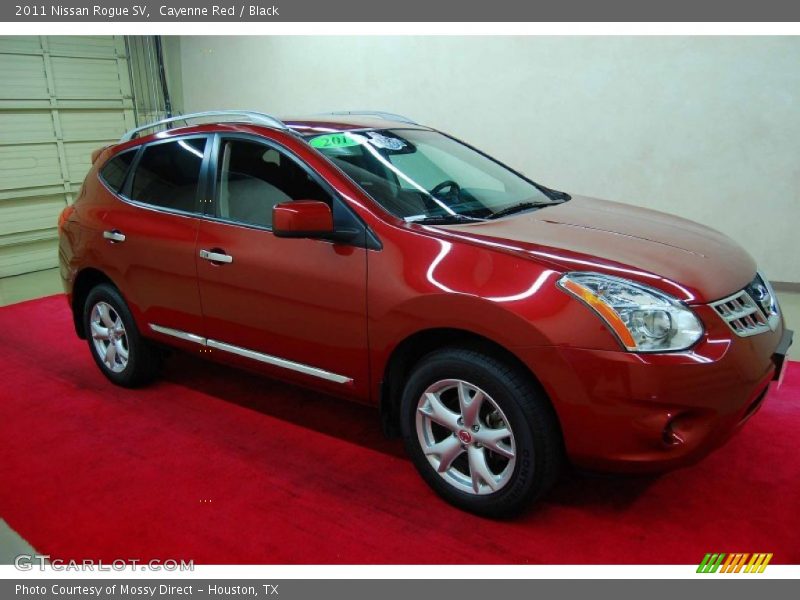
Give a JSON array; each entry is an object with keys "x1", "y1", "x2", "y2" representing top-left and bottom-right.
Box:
[{"x1": 401, "y1": 348, "x2": 563, "y2": 518}]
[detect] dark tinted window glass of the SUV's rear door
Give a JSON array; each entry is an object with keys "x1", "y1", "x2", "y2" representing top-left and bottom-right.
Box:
[{"x1": 131, "y1": 138, "x2": 206, "y2": 212}]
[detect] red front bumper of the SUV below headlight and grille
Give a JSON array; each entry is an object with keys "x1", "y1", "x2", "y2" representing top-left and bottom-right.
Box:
[{"x1": 523, "y1": 307, "x2": 792, "y2": 472}]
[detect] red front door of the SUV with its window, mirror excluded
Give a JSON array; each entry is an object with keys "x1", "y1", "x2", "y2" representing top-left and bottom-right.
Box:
[{"x1": 196, "y1": 135, "x2": 369, "y2": 398}]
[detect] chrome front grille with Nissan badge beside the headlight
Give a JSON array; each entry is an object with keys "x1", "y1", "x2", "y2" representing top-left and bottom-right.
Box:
[{"x1": 711, "y1": 275, "x2": 779, "y2": 337}]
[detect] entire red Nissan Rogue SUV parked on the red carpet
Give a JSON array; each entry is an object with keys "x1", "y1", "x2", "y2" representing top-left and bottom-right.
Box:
[{"x1": 59, "y1": 111, "x2": 792, "y2": 515}]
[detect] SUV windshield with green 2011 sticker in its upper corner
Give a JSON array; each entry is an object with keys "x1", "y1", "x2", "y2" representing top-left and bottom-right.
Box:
[{"x1": 309, "y1": 129, "x2": 569, "y2": 221}]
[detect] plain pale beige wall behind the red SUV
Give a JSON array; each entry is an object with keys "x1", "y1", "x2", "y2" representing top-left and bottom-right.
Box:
[{"x1": 169, "y1": 35, "x2": 800, "y2": 282}]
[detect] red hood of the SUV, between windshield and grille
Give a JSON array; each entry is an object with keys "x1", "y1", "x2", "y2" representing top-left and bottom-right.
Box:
[{"x1": 439, "y1": 196, "x2": 756, "y2": 303}]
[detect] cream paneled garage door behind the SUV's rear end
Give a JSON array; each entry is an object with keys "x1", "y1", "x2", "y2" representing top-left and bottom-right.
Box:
[{"x1": 0, "y1": 36, "x2": 134, "y2": 277}]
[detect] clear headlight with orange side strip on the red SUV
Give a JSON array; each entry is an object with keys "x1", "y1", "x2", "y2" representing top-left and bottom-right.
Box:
[{"x1": 558, "y1": 273, "x2": 703, "y2": 352}]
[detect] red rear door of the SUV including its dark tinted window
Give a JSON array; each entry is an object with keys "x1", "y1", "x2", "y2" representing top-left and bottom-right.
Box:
[{"x1": 100, "y1": 135, "x2": 210, "y2": 340}]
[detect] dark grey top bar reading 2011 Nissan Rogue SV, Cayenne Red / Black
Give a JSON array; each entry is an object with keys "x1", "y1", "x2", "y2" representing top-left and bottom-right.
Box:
[{"x1": 0, "y1": 0, "x2": 800, "y2": 23}]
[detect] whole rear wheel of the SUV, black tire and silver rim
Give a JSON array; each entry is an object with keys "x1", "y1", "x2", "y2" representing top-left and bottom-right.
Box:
[{"x1": 83, "y1": 283, "x2": 161, "y2": 388}]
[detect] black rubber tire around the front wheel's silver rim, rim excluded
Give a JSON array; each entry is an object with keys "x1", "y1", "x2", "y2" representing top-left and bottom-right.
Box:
[{"x1": 401, "y1": 350, "x2": 557, "y2": 517}]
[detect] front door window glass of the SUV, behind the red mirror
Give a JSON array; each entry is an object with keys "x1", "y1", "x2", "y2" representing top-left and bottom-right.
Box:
[{"x1": 217, "y1": 139, "x2": 332, "y2": 227}]
